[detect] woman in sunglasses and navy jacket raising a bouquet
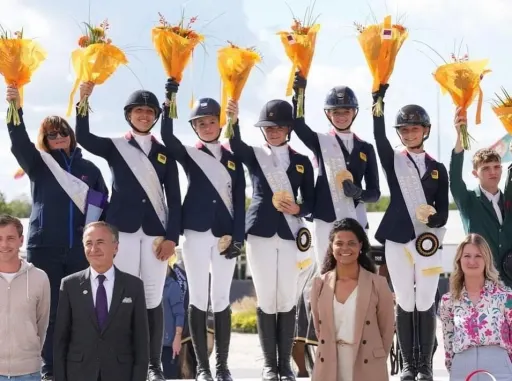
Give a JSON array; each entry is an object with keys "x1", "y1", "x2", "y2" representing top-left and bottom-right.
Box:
[{"x1": 7, "y1": 88, "x2": 108, "y2": 379}]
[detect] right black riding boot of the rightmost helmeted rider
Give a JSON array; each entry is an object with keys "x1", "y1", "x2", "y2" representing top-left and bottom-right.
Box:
[{"x1": 418, "y1": 305, "x2": 436, "y2": 381}]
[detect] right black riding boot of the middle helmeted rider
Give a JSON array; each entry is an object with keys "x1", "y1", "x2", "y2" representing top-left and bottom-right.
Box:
[{"x1": 277, "y1": 307, "x2": 296, "y2": 381}]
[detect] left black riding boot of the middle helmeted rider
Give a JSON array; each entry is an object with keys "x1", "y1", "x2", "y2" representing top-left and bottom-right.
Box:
[{"x1": 257, "y1": 308, "x2": 279, "y2": 381}]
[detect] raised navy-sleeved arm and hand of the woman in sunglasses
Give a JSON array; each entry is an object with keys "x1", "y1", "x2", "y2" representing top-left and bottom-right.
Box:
[{"x1": 6, "y1": 87, "x2": 43, "y2": 177}]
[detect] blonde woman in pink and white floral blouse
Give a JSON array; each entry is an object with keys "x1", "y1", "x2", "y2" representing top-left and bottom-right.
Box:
[{"x1": 440, "y1": 234, "x2": 512, "y2": 381}]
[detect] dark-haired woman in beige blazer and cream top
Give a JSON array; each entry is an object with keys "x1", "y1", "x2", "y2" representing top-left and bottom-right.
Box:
[{"x1": 311, "y1": 218, "x2": 395, "y2": 381}]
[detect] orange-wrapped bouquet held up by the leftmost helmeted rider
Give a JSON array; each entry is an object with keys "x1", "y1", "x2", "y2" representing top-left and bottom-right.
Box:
[{"x1": 67, "y1": 20, "x2": 128, "y2": 116}]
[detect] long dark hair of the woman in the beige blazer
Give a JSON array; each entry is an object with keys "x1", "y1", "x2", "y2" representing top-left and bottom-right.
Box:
[{"x1": 321, "y1": 218, "x2": 377, "y2": 274}]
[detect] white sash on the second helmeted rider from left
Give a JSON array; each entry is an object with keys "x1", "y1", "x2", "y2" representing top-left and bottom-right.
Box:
[{"x1": 185, "y1": 146, "x2": 234, "y2": 218}]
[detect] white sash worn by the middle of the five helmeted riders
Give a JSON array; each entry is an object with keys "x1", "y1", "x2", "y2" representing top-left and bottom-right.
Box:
[{"x1": 252, "y1": 147, "x2": 305, "y2": 238}]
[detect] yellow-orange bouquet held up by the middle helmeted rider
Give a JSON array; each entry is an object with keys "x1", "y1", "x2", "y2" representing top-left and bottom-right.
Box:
[{"x1": 217, "y1": 41, "x2": 261, "y2": 139}]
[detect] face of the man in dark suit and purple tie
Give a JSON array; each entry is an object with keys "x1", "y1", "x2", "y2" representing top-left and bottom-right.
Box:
[{"x1": 83, "y1": 225, "x2": 118, "y2": 274}]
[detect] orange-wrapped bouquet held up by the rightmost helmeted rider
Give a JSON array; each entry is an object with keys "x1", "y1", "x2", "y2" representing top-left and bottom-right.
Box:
[{"x1": 355, "y1": 16, "x2": 409, "y2": 116}]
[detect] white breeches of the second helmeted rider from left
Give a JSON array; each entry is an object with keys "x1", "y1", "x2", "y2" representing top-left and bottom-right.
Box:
[{"x1": 183, "y1": 230, "x2": 236, "y2": 312}]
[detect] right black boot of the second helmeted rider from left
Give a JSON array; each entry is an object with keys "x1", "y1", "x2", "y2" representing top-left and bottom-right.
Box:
[{"x1": 213, "y1": 306, "x2": 233, "y2": 381}]
